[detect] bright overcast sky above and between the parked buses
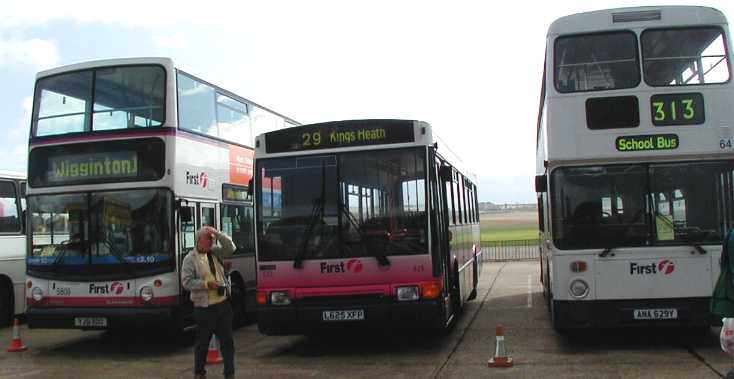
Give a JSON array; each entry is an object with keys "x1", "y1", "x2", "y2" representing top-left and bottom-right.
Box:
[{"x1": 0, "y1": 0, "x2": 734, "y2": 203}]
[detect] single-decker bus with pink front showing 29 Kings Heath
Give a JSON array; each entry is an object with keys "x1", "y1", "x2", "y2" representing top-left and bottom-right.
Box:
[{"x1": 254, "y1": 120, "x2": 482, "y2": 334}]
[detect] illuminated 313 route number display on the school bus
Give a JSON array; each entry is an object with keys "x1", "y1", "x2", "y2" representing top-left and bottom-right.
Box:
[{"x1": 650, "y1": 93, "x2": 704, "y2": 126}]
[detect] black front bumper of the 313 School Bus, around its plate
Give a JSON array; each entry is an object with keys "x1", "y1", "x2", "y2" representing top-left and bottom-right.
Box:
[{"x1": 552, "y1": 297, "x2": 721, "y2": 329}]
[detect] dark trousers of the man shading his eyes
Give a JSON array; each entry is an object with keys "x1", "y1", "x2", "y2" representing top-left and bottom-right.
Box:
[{"x1": 194, "y1": 300, "x2": 234, "y2": 376}]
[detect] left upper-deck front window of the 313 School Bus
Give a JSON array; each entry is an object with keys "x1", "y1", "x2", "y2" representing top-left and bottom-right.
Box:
[{"x1": 554, "y1": 31, "x2": 640, "y2": 93}]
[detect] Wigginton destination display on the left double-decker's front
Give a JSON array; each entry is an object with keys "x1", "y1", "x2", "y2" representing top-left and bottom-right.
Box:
[{"x1": 28, "y1": 138, "x2": 165, "y2": 187}]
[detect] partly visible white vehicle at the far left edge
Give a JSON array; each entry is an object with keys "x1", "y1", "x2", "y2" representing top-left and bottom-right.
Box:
[{"x1": 0, "y1": 170, "x2": 26, "y2": 326}]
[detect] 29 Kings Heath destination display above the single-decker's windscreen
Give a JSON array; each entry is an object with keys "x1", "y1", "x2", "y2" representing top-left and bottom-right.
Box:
[{"x1": 265, "y1": 120, "x2": 415, "y2": 153}]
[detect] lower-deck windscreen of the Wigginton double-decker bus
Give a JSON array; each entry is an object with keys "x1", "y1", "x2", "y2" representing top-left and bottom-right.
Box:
[{"x1": 27, "y1": 189, "x2": 173, "y2": 277}]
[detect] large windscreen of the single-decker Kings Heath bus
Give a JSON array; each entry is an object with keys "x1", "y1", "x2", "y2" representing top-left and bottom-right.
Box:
[{"x1": 256, "y1": 148, "x2": 427, "y2": 261}]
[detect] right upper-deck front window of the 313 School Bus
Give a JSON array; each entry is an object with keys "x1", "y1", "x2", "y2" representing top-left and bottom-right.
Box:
[{"x1": 641, "y1": 27, "x2": 729, "y2": 86}]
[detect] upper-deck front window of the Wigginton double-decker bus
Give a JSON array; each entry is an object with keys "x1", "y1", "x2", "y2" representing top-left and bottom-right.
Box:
[{"x1": 33, "y1": 65, "x2": 166, "y2": 137}]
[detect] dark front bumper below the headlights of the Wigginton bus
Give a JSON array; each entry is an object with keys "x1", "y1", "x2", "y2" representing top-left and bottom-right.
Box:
[{"x1": 26, "y1": 308, "x2": 175, "y2": 330}]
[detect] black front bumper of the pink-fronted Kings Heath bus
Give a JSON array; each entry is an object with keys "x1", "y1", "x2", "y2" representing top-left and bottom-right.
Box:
[{"x1": 257, "y1": 300, "x2": 444, "y2": 335}]
